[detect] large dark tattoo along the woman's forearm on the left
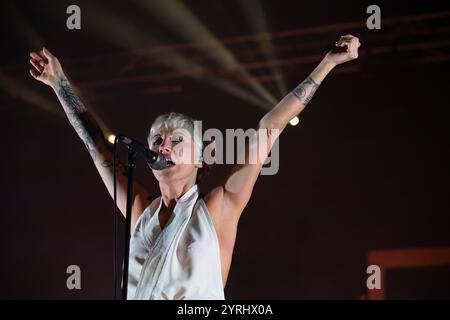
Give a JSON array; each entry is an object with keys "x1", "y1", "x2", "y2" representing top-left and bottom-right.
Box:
[{"x1": 56, "y1": 77, "x2": 104, "y2": 162}]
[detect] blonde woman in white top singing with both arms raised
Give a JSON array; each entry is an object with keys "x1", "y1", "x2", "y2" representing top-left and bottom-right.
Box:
[{"x1": 30, "y1": 35, "x2": 360, "y2": 299}]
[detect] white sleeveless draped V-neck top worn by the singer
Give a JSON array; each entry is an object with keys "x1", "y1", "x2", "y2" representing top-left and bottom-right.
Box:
[{"x1": 127, "y1": 184, "x2": 225, "y2": 300}]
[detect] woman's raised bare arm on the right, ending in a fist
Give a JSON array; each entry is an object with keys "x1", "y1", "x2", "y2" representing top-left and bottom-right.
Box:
[{"x1": 212, "y1": 35, "x2": 360, "y2": 223}]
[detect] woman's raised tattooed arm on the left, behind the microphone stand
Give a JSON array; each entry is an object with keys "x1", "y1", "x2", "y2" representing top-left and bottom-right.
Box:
[{"x1": 30, "y1": 48, "x2": 150, "y2": 226}]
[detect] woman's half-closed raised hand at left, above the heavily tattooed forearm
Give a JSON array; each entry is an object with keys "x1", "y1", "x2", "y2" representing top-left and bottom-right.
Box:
[{"x1": 30, "y1": 48, "x2": 64, "y2": 89}]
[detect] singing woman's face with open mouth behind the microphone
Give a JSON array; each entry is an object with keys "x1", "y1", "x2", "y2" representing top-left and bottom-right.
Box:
[{"x1": 148, "y1": 128, "x2": 199, "y2": 182}]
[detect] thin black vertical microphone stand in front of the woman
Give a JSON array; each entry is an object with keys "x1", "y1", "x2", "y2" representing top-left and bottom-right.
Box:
[{"x1": 122, "y1": 149, "x2": 136, "y2": 300}]
